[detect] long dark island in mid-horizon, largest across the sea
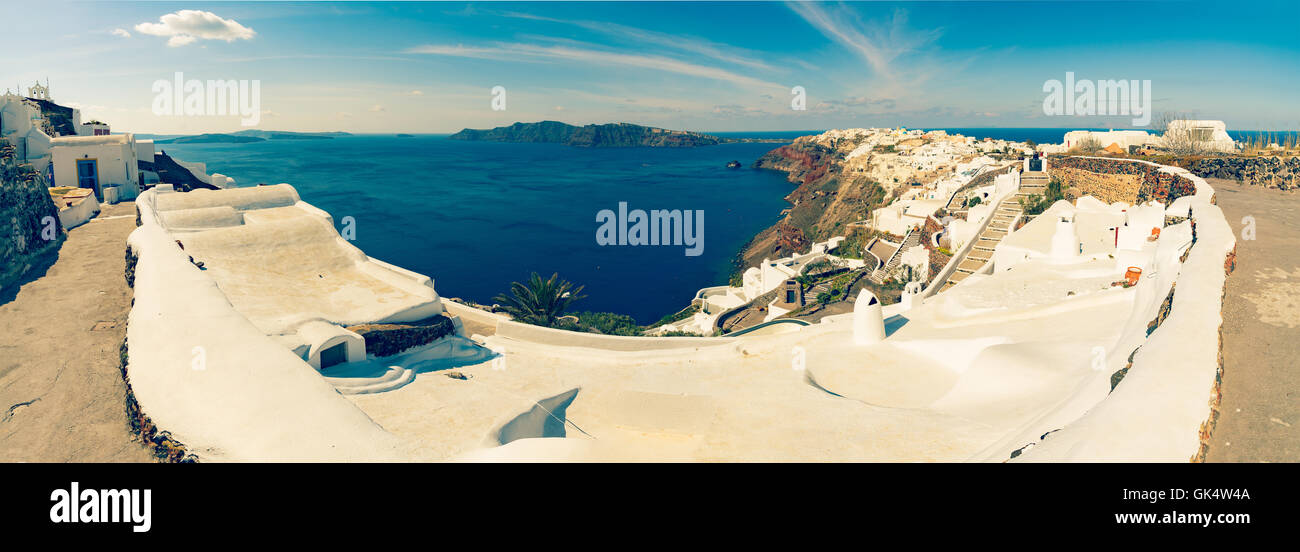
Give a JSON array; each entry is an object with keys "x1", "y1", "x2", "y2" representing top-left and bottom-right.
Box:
[{"x1": 451, "y1": 121, "x2": 740, "y2": 148}]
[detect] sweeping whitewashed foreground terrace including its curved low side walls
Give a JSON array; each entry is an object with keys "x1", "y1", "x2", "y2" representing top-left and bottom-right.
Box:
[{"x1": 129, "y1": 161, "x2": 1235, "y2": 461}]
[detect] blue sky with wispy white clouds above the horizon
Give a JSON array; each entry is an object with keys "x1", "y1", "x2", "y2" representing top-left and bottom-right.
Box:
[{"x1": 10, "y1": 1, "x2": 1300, "y2": 134}]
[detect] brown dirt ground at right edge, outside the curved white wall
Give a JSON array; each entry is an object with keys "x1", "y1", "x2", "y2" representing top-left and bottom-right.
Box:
[{"x1": 1206, "y1": 178, "x2": 1300, "y2": 462}]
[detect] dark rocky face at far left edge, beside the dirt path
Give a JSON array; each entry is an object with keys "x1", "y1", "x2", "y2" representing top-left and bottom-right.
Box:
[{"x1": 0, "y1": 139, "x2": 64, "y2": 288}]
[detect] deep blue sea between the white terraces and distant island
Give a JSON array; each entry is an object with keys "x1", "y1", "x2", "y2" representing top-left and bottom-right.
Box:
[{"x1": 157, "y1": 132, "x2": 801, "y2": 323}]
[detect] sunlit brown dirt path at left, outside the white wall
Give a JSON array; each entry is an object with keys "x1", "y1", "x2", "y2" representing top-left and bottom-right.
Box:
[{"x1": 0, "y1": 203, "x2": 153, "y2": 462}]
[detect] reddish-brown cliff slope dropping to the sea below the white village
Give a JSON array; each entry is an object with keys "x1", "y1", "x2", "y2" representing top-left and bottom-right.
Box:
[{"x1": 737, "y1": 136, "x2": 887, "y2": 268}]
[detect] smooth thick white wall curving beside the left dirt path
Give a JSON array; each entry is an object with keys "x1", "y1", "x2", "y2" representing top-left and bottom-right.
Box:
[{"x1": 126, "y1": 190, "x2": 406, "y2": 461}]
